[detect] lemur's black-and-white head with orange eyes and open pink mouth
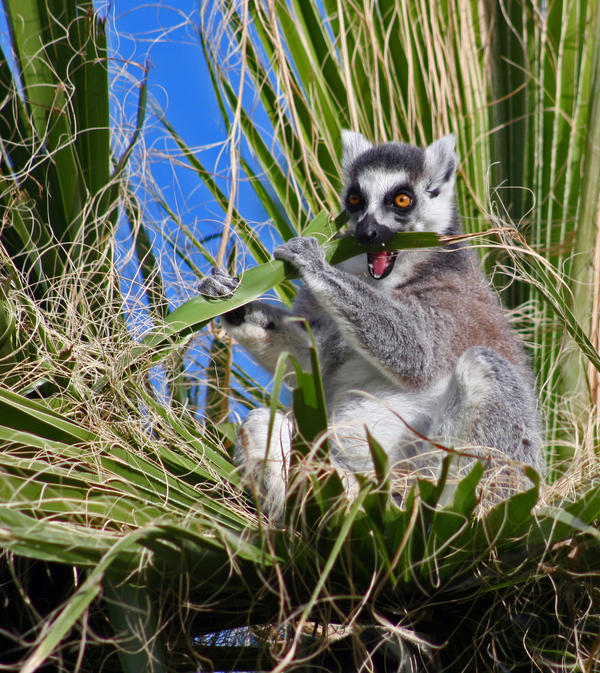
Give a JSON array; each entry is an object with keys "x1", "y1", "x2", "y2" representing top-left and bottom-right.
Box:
[{"x1": 342, "y1": 131, "x2": 459, "y2": 279}]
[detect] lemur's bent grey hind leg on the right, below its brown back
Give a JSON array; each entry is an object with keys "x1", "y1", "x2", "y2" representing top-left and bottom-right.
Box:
[{"x1": 431, "y1": 346, "x2": 541, "y2": 469}]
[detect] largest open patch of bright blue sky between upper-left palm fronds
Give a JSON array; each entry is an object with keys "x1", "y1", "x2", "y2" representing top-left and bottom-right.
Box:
[{"x1": 108, "y1": 0, "x2": 265, "y2": 260}]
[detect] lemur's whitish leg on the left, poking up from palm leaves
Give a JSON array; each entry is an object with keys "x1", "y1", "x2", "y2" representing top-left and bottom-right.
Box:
[{"x1": 235, "y1": 408, "x2": 294, "y2": 518}]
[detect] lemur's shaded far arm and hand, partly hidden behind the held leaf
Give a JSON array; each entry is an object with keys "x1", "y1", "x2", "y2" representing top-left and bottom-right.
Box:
[{"x1": 198, "y1": 267, "x2": 310, "y2": 373}]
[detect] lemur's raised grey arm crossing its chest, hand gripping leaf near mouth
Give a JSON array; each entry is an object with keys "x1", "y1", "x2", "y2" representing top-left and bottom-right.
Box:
[{"x1": 274, "y1": 237, "x2": 435, "y2": 383}]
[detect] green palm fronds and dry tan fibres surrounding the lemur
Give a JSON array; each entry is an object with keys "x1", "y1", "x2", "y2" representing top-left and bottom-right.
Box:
[{"x1": 0, "y1": 0, "x2": 600, "y2": 673}]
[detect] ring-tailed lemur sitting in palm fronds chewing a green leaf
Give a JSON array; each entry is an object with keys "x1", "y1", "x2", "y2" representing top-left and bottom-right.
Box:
[{"x1": 200, "y1": 131, "x2": 541, "y2": 513}]
